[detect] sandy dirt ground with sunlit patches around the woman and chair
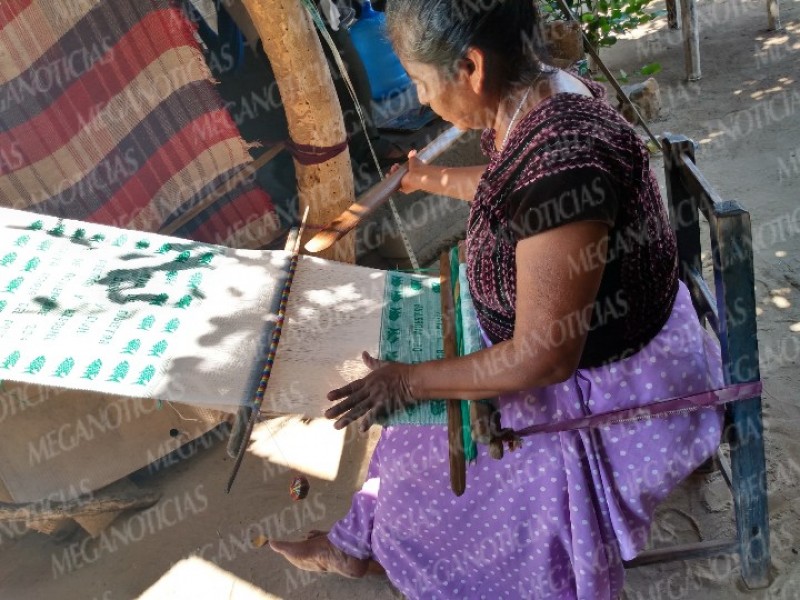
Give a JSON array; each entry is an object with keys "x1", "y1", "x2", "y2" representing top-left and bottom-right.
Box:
[{"x1": 0, "y1": 0, "x2": 800, "y2": 600}]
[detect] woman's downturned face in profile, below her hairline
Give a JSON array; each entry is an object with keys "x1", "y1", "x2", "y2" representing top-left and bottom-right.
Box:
[{"x1": 401, "y1": 59, "x2": 496, "y2": 129}]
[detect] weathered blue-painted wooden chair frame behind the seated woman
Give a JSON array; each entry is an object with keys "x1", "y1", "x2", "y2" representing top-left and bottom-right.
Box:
[{"x1": 626, "y1": 134, "x2": 770, "y2": 588}]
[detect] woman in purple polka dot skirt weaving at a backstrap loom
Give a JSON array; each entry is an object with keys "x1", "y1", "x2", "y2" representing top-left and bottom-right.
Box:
[{"x1": 272, "y1": 0, "x2": 721, "y2": 599}]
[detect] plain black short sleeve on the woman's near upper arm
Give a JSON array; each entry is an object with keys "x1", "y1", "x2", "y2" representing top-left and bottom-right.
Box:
[{"x1": 507, "y1": 166, "x2": 619, "y2": 239}]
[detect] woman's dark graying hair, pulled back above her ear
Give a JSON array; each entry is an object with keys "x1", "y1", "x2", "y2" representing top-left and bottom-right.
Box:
[{"x1": 386, "y1": 0, "x2": 547, "y2": 94}]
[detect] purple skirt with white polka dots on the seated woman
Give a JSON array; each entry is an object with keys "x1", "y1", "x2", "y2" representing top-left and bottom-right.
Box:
[{"x1": 329, "y1": 285, "x2": 722, "y2": 600}]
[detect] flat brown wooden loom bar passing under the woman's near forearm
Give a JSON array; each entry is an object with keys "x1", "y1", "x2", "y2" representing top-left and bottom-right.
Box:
[{"x1": 439, "y1": 252, "x2": 467, "y2": 496}]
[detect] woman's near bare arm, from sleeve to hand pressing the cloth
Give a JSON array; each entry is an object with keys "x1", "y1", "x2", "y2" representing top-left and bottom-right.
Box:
[{"x1": 326, "y1": 221, "x2": 608, "y2": 429}]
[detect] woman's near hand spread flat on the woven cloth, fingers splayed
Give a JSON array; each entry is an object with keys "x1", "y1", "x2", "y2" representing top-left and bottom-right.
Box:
[{"x1": 325, "y1": 352, "x2": 416, "y2": 431}]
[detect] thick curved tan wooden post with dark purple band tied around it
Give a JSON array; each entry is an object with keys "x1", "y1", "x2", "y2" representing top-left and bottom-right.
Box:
[{"x1": 242, "y1": 0, "x2": 355, "y2": 262}]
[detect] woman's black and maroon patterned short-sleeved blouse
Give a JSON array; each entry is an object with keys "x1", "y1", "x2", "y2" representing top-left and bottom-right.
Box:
[{"x1": 467, "y1": 81, "x2": 678, "y2": 368}]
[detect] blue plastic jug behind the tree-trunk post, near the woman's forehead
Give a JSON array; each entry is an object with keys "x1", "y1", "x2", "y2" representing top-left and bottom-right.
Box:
[{"x1": 350, "y1": 0, "x2": 411, "y2": 100}]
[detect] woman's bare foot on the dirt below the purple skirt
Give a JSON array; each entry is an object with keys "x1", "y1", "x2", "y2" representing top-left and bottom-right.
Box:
[{"x1": 269, "y1": 530, "x2": 385, "y2": 579}]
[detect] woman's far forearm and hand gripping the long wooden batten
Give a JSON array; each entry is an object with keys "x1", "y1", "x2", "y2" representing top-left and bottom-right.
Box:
[{"x1": 400, "y1": 150, "x2": 486, "y2": 202}]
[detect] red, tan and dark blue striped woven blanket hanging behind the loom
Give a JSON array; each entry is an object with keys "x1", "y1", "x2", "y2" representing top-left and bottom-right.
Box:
[{"x1": 0, "y1": 0, "x2": 278, "y2": 247}]
